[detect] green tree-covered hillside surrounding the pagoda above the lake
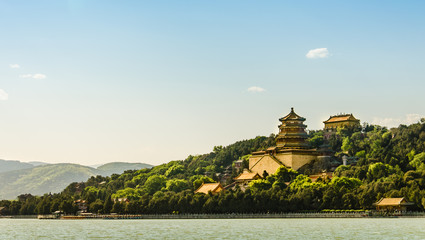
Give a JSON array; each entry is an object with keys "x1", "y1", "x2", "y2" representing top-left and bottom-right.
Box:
[{"x1": 1, "y1": 119, "x2": 425, "y2": 216}]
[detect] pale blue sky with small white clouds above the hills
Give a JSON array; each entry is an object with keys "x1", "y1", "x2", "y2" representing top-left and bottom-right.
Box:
[{"x1": 0, "y1": 0, "x2": 425, "y2": 165}]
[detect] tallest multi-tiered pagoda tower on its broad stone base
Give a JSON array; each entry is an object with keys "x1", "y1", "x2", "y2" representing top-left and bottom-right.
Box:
[{"x1": 249, "y1": 108, "x2": 317, "y2": 176}]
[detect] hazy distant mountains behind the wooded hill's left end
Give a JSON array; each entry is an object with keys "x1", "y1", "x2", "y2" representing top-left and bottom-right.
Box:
[{"x1": 0, "y1": 160, "x2": 153, "y2": 200}]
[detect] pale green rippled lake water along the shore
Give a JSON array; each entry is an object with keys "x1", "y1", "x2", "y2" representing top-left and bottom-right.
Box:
[{"x1": 0, "y1": 218, "x2": 425, "y2": 240}]
